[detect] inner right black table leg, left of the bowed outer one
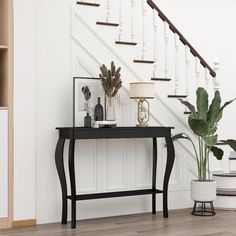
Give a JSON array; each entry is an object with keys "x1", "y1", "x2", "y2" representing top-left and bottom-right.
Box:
[{"x1": 152, "y1": 138, "x2": 157, "y2": 214}]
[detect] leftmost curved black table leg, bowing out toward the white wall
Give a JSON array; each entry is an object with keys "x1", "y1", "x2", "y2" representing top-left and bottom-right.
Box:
[{"x1": 55, "y1": 139, "x2": 67, "y2": 224}]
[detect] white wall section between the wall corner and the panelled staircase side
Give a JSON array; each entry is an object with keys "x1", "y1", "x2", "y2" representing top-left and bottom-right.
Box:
[{"x1": 36, "y1": 0, "x2": 72, "y2": 222}]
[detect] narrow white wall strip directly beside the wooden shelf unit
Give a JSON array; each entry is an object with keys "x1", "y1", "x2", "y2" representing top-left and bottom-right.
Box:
[{"x1": 14, "y1": 0, "x2": 36, "y2": 220}]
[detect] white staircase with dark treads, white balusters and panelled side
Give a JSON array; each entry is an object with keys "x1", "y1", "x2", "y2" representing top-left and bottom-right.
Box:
[{"x1": 71, "y1": 0, "x2": 236, "y2": 216}]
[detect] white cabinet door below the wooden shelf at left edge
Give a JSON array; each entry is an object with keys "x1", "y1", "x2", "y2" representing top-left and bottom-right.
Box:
[{"x1": 0, "y1": 110, "x2": 8, "y2": 218}]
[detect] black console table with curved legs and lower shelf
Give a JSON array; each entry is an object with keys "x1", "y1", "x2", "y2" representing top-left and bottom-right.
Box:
[{"x1": 55, "y1": 127, "x2": 175, "y2": 228}]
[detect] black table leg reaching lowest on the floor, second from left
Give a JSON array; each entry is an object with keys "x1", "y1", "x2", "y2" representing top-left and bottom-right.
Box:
[{"x1": 69, "y1": 139, "x2": 76, "y2": 229}]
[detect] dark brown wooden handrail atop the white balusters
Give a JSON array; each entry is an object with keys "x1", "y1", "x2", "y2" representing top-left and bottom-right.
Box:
[{"x1": 147, "y1": 0, "x2": 216, "y2": 77}]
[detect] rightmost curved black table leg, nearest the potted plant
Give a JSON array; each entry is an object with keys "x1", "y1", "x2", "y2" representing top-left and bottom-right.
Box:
[{"x1": 163, "y1": 136, "x2": 175, "y2": 218}]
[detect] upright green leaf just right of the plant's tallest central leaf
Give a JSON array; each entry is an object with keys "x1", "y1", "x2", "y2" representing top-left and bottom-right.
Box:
[{"x1": 207, "y1": 91, "x2": 221, "y2": 128}]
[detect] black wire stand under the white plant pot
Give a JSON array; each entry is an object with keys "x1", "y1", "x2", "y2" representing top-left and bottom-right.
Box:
[{"x1": 192, "y1": 201, "x2": 216, "y2": 216}]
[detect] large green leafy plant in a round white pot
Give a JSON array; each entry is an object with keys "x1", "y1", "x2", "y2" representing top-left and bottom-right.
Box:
[{"x1": 172, "y1": 88, "x2": 236, "y2": 202}]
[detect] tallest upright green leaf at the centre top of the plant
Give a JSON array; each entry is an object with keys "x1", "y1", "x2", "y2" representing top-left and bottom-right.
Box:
[{"x1": 197, "y1": 88, "x2": 208, "y2": 120}]
